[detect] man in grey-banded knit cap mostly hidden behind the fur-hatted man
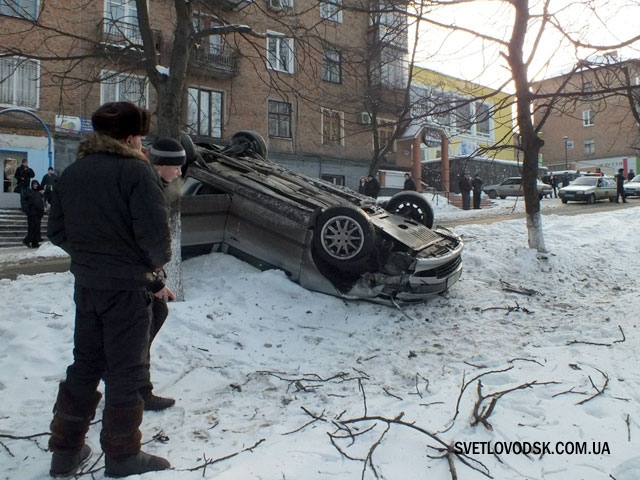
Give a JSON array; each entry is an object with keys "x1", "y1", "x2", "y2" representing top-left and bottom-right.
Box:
[{"x1": 140, "y1": 138, "x2": 187, "y2": 411}]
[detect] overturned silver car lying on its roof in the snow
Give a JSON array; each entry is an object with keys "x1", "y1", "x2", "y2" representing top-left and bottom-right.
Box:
[{"x1": 181, "y1": 132, "x2": 463, "y2": 304}]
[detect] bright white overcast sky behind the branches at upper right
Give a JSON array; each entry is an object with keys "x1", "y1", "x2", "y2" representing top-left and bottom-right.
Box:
[{"x1": 417, "y1": 0, "x2": 640, "y2": 87}]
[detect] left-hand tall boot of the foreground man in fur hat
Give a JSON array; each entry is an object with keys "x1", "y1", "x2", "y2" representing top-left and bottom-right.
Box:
[{"x1": 49, "y1": 382, "x2": 102, "y2": 477}]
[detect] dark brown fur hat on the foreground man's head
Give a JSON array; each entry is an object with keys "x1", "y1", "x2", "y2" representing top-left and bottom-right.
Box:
[{"x1": 91, "y1": 102, "x2": 151, "y2": 140}]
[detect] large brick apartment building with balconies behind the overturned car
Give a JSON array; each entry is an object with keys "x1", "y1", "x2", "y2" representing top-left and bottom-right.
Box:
[{"x1": 0, "y1": 0, "x2": 407, "y2": 193}]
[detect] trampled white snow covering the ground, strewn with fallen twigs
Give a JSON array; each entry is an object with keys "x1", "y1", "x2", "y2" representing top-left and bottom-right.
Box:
[{"x1": 0, "y1": 199, "x2": 640, "y2": 480}]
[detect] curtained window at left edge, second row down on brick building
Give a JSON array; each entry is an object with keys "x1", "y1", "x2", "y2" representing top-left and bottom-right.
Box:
[{"x1": 0, "y1": 57, "x2": 40, "y2": 109}]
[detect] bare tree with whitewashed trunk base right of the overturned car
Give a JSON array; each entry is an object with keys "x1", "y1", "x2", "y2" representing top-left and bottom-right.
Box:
[{"x1": 410, "y1": 0, "x2": 640, "y2": 251}]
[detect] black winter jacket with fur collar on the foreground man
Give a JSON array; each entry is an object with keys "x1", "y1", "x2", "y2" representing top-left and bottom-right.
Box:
[{"x1": 47, "y1": 133, "x2": 171, "y2": 290}]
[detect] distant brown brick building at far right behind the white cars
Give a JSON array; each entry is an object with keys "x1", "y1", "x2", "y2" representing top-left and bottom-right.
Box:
[{"x1": 534, "y1": 58, "x2": 640, "y2": 175}]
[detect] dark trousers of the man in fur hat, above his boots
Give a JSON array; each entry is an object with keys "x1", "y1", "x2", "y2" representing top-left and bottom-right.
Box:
[{"x1": 66, "y1": 285, "x2": 153, "y2": 405}]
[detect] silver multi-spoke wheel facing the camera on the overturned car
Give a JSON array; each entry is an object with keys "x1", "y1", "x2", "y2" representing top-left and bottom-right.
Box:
[{"x1": 313, "y1": 205, "x2": 375, "y2": 271}]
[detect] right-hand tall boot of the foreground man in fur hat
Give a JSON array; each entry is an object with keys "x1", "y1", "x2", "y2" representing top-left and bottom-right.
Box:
[{"x1": 100, "y1": 401, "x2": 171, "y2": 477}]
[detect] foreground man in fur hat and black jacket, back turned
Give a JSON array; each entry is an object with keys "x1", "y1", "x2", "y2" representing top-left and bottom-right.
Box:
[{"x1": 48, "y1": 102, "x2": 171, "y2": 477}]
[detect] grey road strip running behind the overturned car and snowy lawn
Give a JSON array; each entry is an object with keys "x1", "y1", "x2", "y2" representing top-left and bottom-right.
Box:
[{"x1": 0, "y1": 199, "x2": 640, "y2": 280}]
